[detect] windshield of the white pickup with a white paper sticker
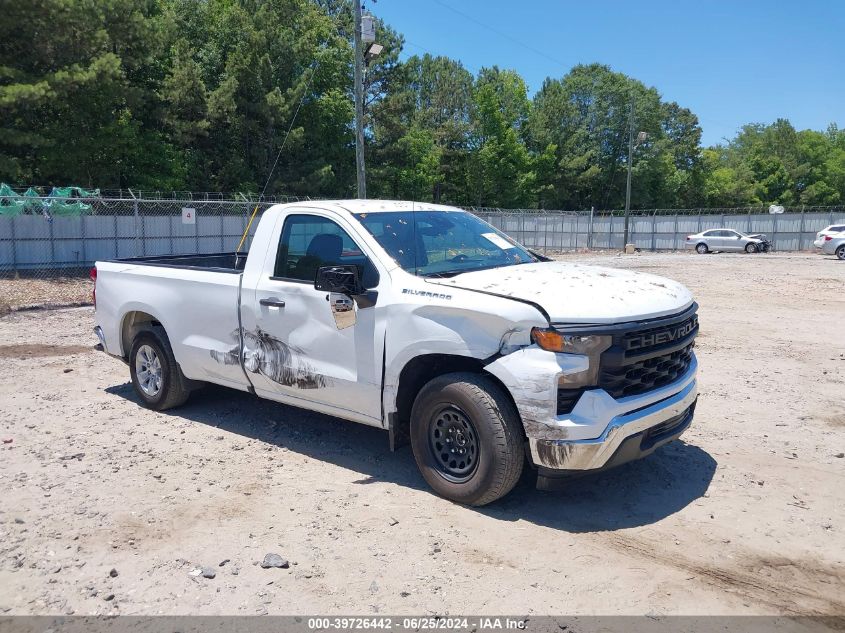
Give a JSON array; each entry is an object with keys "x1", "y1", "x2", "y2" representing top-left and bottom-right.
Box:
[{"x1": 355, "y1": 211, "x2": 537, "y2": 277}]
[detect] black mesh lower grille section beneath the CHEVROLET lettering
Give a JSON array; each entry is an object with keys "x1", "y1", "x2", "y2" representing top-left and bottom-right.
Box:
[{"x1": 599, "y1": 343, "x2": 694, "y2": 398}]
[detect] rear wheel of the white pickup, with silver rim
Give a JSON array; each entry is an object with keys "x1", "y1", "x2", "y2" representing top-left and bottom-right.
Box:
[{"x1": 129, "y1": 327, "x2": 191, "y2": 411}]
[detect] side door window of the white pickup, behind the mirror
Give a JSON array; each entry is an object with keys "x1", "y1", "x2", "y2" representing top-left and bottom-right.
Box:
[{"x1": 273, "y1": 215, "x2": 378, "y2": 288}]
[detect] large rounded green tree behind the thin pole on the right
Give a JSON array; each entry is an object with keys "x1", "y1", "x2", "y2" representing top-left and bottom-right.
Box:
[{"x1": 528, "y1": 64, "x2": 701, "y2": 209}]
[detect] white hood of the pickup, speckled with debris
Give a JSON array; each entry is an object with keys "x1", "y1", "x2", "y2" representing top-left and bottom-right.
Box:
[{"x1": 428, "y1": 262, "x2": 693, "y2": 323}]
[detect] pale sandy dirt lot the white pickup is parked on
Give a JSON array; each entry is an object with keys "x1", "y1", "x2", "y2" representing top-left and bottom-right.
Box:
[{"x1": 0, "y1": 249, "x2": 845, "y2": 615}]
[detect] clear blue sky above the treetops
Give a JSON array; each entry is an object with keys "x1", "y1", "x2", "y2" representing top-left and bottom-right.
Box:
[{"x1": 372, "y1": 0, "x2": 845, "y2": 145}]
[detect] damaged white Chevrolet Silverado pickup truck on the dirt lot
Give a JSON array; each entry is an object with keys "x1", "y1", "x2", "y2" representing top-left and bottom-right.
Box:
[{"x1": 92, "y1": 200, "x2": 698, "y2": 505}]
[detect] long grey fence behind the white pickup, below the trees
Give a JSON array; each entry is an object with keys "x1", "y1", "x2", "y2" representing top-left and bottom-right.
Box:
[{"x1": 0, "y1": 190, "x2": 845, "y2": 279}]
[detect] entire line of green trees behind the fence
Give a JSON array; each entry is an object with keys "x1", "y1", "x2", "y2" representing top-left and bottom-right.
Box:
[{"x1": 0, "y1": 0, "x2": 845, "y2": 209}]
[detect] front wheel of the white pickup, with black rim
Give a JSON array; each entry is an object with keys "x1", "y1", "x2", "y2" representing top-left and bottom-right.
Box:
[{"x1": 411, "y1": 373, "x2": 525, "y2": 506}]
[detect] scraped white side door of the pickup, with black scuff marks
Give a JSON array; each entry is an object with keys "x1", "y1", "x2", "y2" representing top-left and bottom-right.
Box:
[{"x1": 237, "y1": 210, "x2": 384, "y2": 426}]
